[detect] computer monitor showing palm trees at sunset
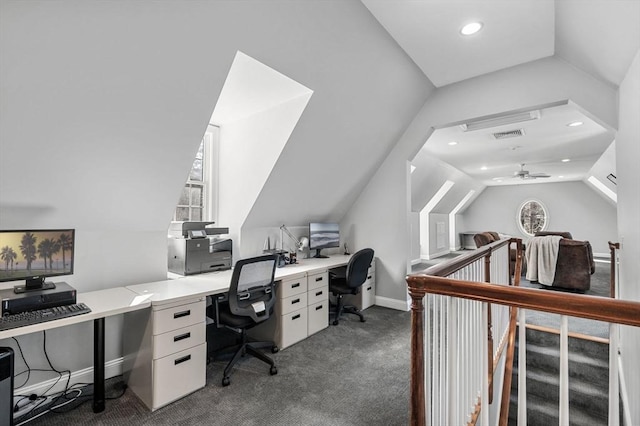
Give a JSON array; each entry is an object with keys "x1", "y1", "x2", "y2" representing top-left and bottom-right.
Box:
[{"x1": 0, "y1": 229, "x2": 75, "y2": 293}]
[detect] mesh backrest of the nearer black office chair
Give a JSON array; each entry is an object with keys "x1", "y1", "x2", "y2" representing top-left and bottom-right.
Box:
[{"x1": 229, "y1": 254, "x2": 277, "y2": 322}]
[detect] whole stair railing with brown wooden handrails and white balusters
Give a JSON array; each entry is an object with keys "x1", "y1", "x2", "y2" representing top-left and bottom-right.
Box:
[{"x1": 407, "y1": 239, "x2": 640, "y2": 426}]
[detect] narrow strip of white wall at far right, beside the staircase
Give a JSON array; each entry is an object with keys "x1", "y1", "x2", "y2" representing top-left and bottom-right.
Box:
[{"x1": 616, "y1": 51, "x2": 640, "y2": 425}]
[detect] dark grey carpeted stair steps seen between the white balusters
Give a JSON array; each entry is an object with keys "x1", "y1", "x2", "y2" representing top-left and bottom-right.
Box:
[{"x1": 509, "y1": 328, "x2": 609, "y2": 426}]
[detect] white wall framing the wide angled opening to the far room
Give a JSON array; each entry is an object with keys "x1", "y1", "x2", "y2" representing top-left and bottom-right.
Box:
[{"x1": 344, "y1": 58, "x2": 617, "y2": 301}]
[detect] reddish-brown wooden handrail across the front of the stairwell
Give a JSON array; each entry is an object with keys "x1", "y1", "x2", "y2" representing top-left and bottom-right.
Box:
[{"x1": 407, "y1": 274, "x2": 640, "y2": 327}]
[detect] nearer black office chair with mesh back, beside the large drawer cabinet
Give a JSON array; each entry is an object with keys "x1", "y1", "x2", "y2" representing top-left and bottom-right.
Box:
[{"x1": 216, "y1": 255, "x2": 278, "y2": 386}]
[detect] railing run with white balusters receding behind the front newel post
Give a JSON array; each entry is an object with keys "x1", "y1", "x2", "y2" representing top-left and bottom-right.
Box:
[{"x1": 409, "y1": 240, "x2": 519, "y2": 424}]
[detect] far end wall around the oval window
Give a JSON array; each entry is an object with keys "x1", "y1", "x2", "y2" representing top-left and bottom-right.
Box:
[{"x1": 459, "y1": 181, "x2": 618, "y2": 253}]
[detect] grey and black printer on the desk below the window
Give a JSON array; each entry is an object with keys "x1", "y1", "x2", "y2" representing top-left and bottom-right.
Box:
[{"x1": 168, "y1": 221, "x2": 233, "y2": 275}]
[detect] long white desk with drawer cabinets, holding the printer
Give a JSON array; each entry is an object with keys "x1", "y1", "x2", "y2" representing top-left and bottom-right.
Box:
[{"x1": 123, "y1": 255, "x2": 358, "y2": 410}]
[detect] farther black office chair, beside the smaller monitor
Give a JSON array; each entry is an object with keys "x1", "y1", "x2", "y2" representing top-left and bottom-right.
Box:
[{"x1": 329, "y1": 248, "x2": 373, "y2": 325}]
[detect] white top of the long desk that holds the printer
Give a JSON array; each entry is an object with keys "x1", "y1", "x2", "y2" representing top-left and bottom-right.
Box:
[{"x1": 127, "y1": 255, "x2": 351, "y2": 306}]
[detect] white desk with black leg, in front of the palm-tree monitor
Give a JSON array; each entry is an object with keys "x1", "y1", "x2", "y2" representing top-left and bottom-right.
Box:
[{"x1": 0, "y1": 287, "x2": 151, "y2": 413}]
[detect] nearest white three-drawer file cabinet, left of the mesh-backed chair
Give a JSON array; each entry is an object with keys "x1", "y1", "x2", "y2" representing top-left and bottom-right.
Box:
[{"x1": 124, "y1": 298, "x2": 207, "y2": 410}]
